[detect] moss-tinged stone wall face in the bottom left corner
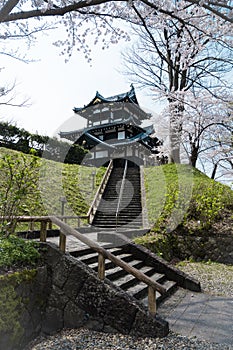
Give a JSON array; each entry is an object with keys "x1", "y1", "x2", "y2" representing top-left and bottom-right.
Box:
[{"x1": 0, "y1": 266, "x2": 47, "y2": 350}]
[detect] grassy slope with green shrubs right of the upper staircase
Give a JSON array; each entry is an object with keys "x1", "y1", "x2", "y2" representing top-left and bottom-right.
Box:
[{"x1": 137, "y1": 164, "x2": 233, "y2": 244}]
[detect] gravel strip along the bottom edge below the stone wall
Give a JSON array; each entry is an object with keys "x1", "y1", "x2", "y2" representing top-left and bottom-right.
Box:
[{"x1": 27, "y1": 329, "x2": 232, "y2": 350}]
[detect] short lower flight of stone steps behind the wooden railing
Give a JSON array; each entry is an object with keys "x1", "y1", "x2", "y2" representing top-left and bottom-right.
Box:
[{"x1": 70, "y1": 238, "x2": 200, "y2": 312}]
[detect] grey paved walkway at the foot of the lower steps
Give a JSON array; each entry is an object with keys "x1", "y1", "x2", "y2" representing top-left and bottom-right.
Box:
[{"x1": 158, "y1": 290, "x2": 233, "y2": 349}]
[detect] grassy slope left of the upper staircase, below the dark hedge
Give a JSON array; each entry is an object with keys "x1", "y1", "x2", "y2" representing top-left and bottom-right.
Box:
[{"x1": 0, "y1": 148, "x2": 105, "y2": 224}]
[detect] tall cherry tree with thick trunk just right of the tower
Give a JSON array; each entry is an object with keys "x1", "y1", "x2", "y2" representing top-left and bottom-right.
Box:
[{"x1": 123, "y1": 2, "x2": 233, "y2": 166}]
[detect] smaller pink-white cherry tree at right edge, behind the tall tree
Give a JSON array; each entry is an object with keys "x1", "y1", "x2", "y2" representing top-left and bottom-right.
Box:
[{"x1": 179, "y1": 91, "x2": 233, "y2": 167}]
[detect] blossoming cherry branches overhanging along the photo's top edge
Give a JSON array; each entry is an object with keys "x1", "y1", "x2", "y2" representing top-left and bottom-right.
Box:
[{"x1": 0, "y1": 0, "x2": 233, "y2": 59}]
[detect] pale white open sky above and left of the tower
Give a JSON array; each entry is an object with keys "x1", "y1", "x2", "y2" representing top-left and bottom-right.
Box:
[{"x1": 0, "y1": 33, "x2": 161, "y2": 136}]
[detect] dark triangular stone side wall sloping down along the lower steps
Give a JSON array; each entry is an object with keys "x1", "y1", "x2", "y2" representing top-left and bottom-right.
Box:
[{"x1": 42, "y1": 244, "x2": 168, "y2": 337}]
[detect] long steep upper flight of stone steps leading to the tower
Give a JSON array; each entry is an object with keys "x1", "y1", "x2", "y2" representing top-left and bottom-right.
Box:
[{"x1": 92, "y1": 165, "x2": 142, "y2": 230}]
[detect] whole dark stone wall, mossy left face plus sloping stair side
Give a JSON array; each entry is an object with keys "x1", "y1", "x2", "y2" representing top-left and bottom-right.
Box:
[{"x1": 0, "y1": 243, "x2": 169, "y2": 350}]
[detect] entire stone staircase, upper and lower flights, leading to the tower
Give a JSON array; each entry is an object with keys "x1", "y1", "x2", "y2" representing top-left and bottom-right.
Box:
[{"x1": 84, "y1": 163, "x2": 200, "y2": 306}]
